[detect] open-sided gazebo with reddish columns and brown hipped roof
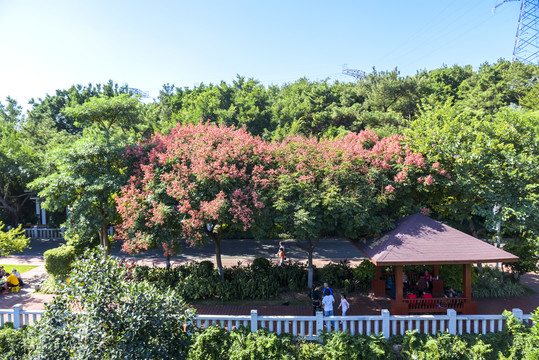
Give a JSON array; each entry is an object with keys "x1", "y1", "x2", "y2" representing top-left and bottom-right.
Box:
[{"x1": 357, "y1": 214, "x2": 518, "y2": 315}]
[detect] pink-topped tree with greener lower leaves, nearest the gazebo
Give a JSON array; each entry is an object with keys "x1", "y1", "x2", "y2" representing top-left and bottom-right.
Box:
[{"x1": 273, "y1": 130, "x2": 435, "y2": 287}]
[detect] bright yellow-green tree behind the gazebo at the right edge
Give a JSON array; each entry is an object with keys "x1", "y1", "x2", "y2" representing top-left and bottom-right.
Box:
[{"x1": 406, "y1": 102, "x2": 539, "y2": 242}]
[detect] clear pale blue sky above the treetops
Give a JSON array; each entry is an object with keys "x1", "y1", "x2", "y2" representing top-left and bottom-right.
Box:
[{"x1": 0, "y1": 0, "x2": 520, "y2": 109}]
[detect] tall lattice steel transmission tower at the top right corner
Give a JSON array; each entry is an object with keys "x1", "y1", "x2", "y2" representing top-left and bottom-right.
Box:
[{"x1": 494, "y1": 0, "x2": 539, "y2": 64}]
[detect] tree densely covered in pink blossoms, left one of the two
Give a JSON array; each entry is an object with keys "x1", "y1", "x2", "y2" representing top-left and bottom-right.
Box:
[{"x1": 117, "y1": 124, "x2": 271, "y2": 278}]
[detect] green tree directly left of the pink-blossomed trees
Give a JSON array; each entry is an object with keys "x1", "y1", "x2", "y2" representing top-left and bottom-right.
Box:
[{"x1": 29, "y1": 138, "x2": 128, "y2": 254}]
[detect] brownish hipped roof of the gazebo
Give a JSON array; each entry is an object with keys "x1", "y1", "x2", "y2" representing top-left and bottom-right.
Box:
[{"x1": 357, "y1": 214, "x2": 518, "y2": 266}]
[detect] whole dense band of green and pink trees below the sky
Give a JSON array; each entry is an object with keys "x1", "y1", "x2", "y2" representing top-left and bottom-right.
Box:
[{"x1": 0, "y1": 60, "x2": 539, "y2": 276}]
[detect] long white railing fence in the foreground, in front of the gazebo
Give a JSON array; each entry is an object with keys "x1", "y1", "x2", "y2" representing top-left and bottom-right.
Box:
[{"x1": 0, "y1": 305, "x2": 532, "y2": 340}]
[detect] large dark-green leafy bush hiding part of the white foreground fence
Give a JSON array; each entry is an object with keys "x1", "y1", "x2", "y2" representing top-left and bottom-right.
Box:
[{"x1": 30, "y1": 252, "x2": 193, "y2": 359}]
